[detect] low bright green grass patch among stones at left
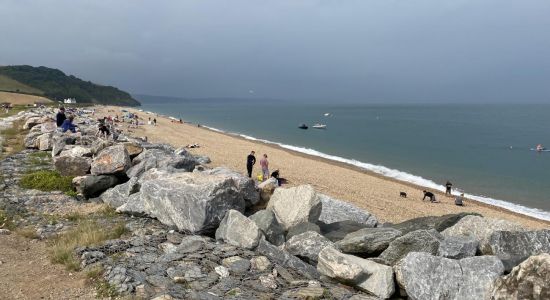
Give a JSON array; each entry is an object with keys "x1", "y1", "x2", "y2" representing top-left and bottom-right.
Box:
[{"x1": 19, "y1": 170, "x2": 74, "y2": 193}]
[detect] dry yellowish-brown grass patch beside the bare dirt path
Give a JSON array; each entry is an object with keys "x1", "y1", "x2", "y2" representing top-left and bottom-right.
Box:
[{"x1": 49, "y1": 219, "x2": 126, "y2": 271}]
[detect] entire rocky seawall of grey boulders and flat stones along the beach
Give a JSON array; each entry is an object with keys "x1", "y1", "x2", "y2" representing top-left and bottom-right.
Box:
[{"x1": 0, "y1": 109, "x2": 550, "y2": 299}]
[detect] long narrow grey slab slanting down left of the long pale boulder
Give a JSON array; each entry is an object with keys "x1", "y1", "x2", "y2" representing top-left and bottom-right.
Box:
[{"x1": 256, "y1": 239, "x2": 319, "y2": 279}]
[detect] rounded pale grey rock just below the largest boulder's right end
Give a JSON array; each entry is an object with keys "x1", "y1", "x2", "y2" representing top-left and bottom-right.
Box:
[{"x1": 216, "y1": 210, "x2": 262, "y2": 249}]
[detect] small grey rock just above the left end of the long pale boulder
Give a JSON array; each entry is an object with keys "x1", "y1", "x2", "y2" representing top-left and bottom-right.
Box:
[{"x1": 285, "y1": 231, "x2": 333, "y2": 263}]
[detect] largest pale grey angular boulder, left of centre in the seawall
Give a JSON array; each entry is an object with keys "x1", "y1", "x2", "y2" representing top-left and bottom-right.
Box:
[{"x1": 117, "y1": 172, "x2": 245, "y2": 233}]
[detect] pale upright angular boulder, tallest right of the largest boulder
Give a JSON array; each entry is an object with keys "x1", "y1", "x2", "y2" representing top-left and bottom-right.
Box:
[{"x1": 267, "y1": 185, "x2": 322, "y2": 230}]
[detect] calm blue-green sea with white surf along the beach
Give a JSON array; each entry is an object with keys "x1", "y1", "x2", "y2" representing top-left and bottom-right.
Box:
[{"x1": 137, "y1": 96, "x2": 550, "y2": 220}]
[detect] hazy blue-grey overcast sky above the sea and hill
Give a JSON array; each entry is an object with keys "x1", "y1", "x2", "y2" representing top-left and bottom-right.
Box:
[{"x1": 0, "y1": 0, "x2": 550, "y2": 103}]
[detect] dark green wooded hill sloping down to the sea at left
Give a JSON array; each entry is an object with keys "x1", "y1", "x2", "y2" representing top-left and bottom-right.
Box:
[{"x1": 0, "y1": 66, "x2": 140, "y2": 106}]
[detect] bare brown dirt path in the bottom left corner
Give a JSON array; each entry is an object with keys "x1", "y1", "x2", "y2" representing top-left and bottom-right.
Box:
[{"x1": 0, "y1": 234, "x2": 96, "y2": 300}]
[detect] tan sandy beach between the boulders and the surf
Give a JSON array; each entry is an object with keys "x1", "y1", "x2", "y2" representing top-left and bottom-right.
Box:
[{"x1": 95, "y1": 106, "x2": 550, "y2": 228}]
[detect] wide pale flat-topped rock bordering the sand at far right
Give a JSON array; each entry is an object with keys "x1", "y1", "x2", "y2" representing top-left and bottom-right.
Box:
[{"x1": 441, "y1": 216, "x2": 525, "y2": 249}]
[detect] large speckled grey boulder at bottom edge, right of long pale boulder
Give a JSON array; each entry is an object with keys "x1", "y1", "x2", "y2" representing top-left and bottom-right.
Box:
[{"x1": 394, "y1": 252, "x2": 504, "y2": 300}]
